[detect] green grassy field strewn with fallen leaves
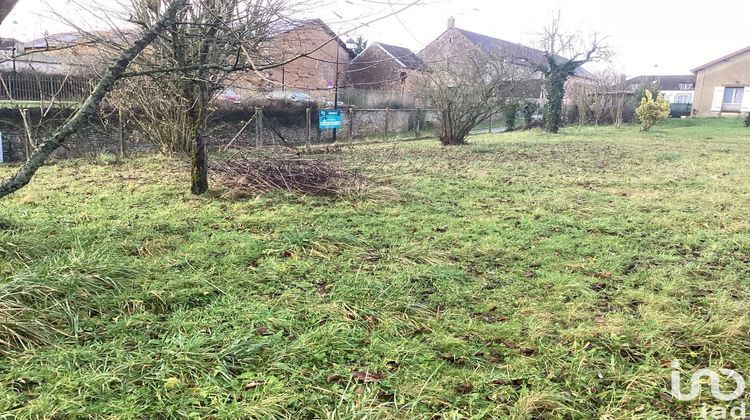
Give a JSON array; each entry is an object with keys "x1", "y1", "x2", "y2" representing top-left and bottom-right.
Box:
[{"x1": 0, "y1": 120, "x2": 750, "y2": 419}]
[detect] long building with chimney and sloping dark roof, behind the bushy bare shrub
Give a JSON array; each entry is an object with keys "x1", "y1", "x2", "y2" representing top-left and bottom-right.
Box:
[{"x1": 418, "y1": 17, "x2": 594, "y2": 100}]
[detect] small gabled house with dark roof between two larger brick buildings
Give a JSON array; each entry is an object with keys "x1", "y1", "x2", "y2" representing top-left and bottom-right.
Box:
[{"x1": 348, "y1": 42, "x2": 424, "y2": 90}]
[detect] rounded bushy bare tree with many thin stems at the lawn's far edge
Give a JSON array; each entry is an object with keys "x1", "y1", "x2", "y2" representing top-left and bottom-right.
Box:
[{"x1": 415, "y1": 52, "x2": 530, "y2": 145}]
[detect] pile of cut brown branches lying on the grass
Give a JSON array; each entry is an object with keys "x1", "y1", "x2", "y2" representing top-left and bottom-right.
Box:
[{"x1": 212, "y1": 155, "x2": 364, "y2": 198}]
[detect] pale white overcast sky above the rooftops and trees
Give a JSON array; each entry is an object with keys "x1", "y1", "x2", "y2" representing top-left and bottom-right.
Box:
[{"x1": 0, "y1": 0, "x2": 750, "y2": 76}]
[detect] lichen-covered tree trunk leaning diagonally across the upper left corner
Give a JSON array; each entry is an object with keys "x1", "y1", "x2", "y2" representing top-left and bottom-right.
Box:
[{"x1": 0, "y1": 0, "x2": 187, "y2": 198}]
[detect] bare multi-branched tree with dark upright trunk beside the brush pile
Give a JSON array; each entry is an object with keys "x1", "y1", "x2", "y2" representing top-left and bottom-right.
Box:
[{"x1": 107, "y1": 0, "x2": 288, "y2": 194}]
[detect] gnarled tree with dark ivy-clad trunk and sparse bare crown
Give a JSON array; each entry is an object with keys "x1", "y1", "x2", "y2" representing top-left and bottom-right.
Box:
[{"x1": 536, "y1": 12, "x2": 611, "y2": 133}]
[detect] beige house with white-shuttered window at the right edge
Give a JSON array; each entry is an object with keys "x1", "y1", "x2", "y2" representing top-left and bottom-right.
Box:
[{"x1": 692, "y1": 47, "x2": 750, "y2": 117}]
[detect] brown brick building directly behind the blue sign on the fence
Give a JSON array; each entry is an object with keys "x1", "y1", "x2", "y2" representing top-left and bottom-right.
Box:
[{"x1": 241, "y1": 19, "x2": 354, "y2": 98}]
